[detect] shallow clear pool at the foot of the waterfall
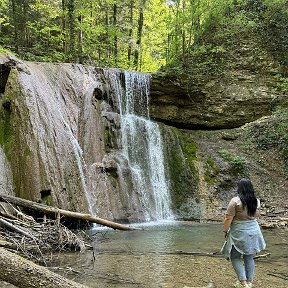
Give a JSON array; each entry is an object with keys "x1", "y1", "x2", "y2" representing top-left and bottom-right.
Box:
[{"x1": 49, "y1": 222, "x2": 288, "y2": 288}]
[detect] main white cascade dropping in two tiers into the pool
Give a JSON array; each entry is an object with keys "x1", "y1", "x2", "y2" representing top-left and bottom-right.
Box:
[{"x1": 110, "y1": 71, "x2": 173, "y2": 221}]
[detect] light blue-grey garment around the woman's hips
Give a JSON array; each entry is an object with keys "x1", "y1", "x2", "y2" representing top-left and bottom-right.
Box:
[{"x1": 221, "y1": 220, "x2": 266, "y2": 260}]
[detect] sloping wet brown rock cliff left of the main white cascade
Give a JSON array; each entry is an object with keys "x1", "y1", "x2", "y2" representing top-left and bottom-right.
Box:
[{"x1": 0, "y1": 55, "x2": 141, "y2": 221}]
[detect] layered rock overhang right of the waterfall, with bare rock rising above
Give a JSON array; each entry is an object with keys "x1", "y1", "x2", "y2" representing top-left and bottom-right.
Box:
[{"x1": 150, "y1": 39, "x2": 288, "y2": 129}]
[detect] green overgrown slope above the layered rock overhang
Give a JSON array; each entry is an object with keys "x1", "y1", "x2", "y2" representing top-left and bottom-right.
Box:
[{"x1": 166, "y1": 0, "x2": 288, "y2": 78}]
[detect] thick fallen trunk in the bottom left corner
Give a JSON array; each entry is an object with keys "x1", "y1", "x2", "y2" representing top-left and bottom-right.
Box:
[{"x1": 0, "y1": 248, "x2": 88, "y2": 288}]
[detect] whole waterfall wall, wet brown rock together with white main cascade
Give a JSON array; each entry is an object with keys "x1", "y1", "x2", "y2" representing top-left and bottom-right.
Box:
[{"x1": 0, "y1": 56, "x2": 172, "y2": 222}]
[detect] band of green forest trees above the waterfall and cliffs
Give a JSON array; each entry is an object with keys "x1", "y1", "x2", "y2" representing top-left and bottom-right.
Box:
[{"x1": 0, "y1": 0, "x2": 288, "y2": 72}]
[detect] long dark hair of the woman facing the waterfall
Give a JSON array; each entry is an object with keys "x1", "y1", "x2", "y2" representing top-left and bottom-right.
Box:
[{"x1": 237, "y1": 178, "x2": 257, "y2": 216}]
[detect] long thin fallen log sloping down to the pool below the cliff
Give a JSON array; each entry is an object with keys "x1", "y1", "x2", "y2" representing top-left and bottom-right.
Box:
[{"x1": 0, "y1": 194, "x2": 137, "y2": 231}]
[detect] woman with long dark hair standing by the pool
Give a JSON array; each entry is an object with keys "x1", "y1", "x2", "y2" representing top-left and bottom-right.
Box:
[{"x1": 222, "y1": 178, "x2": 266, "y2": 288}]
